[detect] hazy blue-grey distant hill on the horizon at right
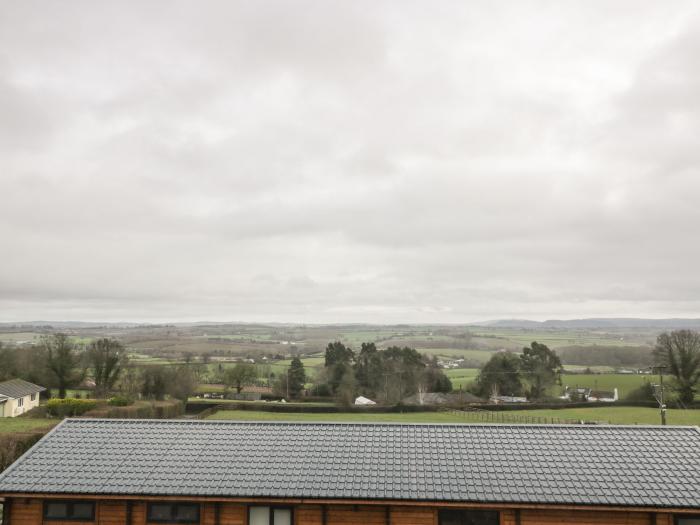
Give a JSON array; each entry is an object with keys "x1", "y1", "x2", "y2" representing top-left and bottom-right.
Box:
[{"x1": 474, "y1": 317, "x2": 700, "y2": 329}]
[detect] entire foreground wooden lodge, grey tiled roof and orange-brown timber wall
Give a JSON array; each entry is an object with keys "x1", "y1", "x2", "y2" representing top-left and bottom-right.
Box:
[{"x1": 0, "y1": 419, "x2": 700, "y2": 525}]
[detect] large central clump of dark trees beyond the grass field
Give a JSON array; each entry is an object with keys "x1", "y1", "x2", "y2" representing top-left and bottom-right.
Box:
[{"x1": 315, "y1": 341, "x2": 452, "y2": 405}]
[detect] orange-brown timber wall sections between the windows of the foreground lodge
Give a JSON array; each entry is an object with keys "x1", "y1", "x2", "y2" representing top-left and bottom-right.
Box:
[{"x1": 3, "y1": 498, "x2": 673, "y2": 525}]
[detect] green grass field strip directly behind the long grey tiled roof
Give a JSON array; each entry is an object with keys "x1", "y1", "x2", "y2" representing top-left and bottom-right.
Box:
[{"x1": 207, "y1": 407, "x2": 700, "y2": 425}]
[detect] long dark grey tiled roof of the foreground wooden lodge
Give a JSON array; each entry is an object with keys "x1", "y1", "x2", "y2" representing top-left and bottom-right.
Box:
[{"x1": 0, "y1": 419, "x2": 700, "y2": 509}]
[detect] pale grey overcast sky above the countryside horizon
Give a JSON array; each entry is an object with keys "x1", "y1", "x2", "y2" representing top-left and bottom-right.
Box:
[{"x1": 0, "y1": 0, "x2": 700, "y2": 323}]
